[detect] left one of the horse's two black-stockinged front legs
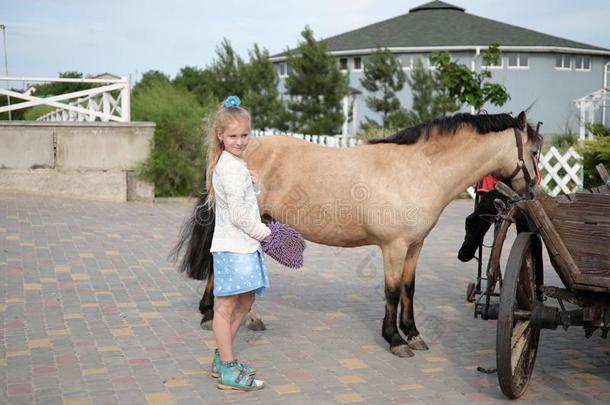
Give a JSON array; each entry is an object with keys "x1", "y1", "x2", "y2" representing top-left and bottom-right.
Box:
[{"x1": 381, "y1": 243, "x2": 413, "y2": 357}]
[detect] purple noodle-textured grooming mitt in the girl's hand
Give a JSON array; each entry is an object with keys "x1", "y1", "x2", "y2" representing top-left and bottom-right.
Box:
[{"x1": 261, "y1": 222, "x2": 305, "y2": 269}]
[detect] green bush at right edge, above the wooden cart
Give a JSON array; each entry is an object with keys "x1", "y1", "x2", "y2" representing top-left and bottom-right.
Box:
[{"x1": 578, "y1": 125, "x2": 610, "y2": 188}]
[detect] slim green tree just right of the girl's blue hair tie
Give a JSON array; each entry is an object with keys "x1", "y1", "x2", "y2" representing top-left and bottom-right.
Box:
[{"x1": 242, "y1": 44, "x2": 283, "y2": 129}]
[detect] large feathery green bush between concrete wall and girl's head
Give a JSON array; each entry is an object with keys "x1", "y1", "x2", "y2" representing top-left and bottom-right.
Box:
[{"x1": 131, "y1": 81, "x2": 214, "y2": 197}]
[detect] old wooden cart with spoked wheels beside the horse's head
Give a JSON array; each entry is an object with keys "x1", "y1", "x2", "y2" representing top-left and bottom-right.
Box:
[{"x1": 475, "y1": 177, "x2": 610, "y2": 398}]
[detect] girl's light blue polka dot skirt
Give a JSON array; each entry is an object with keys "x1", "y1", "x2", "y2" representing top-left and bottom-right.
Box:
[{"x1": 212, "y1": 246, "x2": 269, "y2": 297}]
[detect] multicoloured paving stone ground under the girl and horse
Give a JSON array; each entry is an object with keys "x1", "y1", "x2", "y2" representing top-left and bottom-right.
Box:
[{"x1": 0, "y1": 194, "x2": 610, "y2": 405}]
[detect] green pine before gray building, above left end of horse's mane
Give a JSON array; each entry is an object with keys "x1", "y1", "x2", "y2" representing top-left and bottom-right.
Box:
[{"x1": 360, "y1": 48, "x2": 406, "y2": 128}]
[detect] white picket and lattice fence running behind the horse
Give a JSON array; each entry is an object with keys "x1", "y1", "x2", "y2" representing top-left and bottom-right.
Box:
[{"x1": 252, "y1": 130, "x2": 584, "y2": 198}]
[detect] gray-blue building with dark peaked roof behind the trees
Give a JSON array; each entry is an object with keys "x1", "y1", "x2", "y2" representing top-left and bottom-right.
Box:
[{"x1": 271, "y1": 1, "x2": 610, "y2": 135}]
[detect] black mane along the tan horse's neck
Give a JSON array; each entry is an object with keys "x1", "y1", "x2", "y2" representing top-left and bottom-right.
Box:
[{"x1": 367, "y1": 113, "x2": 536, "y2": 145}]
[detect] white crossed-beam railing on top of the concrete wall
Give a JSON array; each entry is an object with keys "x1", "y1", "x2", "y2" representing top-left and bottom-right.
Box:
[{"x1": 0, "y1": 76, "x2": 131, "y2": 122}]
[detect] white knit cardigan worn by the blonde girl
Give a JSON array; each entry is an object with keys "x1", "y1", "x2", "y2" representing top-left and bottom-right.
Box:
[{"x1": 210, "y1": 151, "x2": 271, "y2": 253}]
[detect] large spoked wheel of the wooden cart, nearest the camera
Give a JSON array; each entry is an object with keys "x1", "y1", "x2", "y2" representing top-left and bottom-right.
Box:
[{"x1": 496, "y1": 232, "x2": 540, "y2": 398}]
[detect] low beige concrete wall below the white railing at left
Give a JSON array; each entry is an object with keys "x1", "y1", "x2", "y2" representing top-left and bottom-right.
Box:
[{"x1": 0, "y1": 121, "x2": 155, "y2": 201}]
